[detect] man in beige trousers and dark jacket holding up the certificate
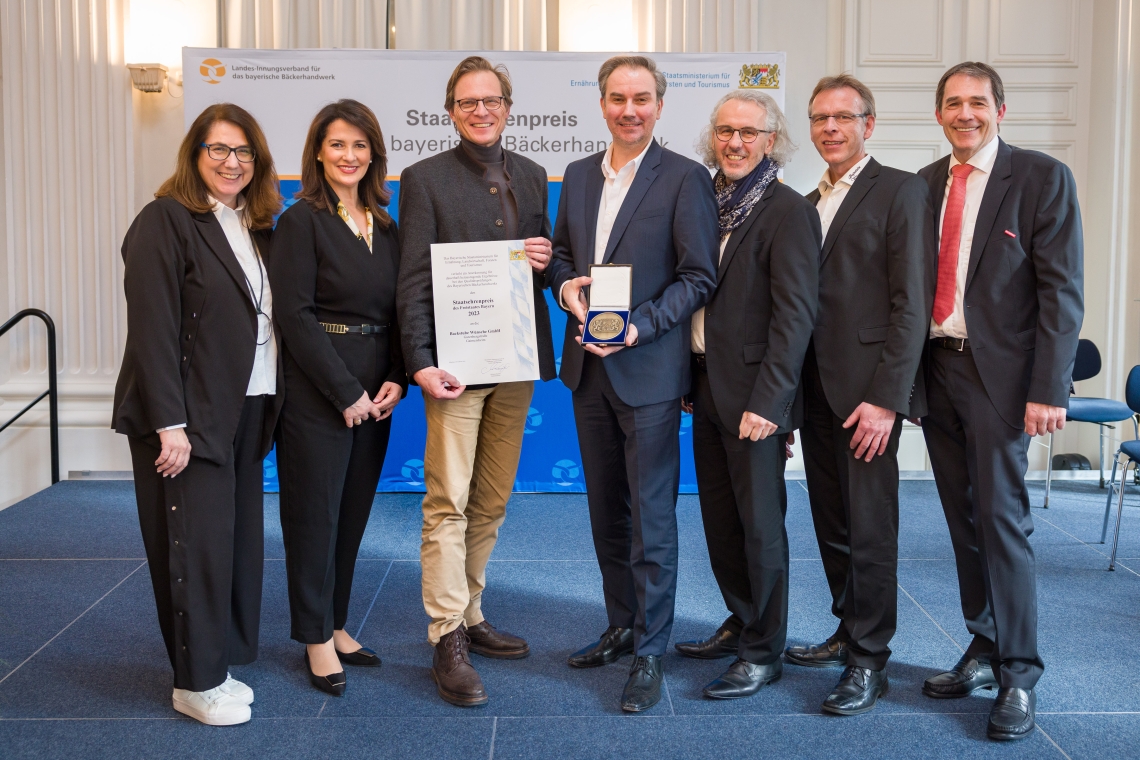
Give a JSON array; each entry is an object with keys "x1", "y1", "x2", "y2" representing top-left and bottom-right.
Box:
[{"x1": 397, "y1": 56, "x2": 554, "y2": 706}]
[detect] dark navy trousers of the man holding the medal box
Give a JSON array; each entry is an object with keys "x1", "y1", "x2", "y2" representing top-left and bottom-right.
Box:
[{"x1": 573, "y1": 354, "x2": 681, "y2": 655}]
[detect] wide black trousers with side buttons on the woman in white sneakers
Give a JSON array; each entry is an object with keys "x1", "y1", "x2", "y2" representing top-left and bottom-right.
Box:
[{"x1": 128, "y1": 395, "x2": 268, "y2": 692}]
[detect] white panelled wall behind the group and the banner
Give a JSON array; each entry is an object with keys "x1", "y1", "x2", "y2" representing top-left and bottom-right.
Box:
[{"x1": 0, "y1": 0, "x2": 1140, "y2": 506}]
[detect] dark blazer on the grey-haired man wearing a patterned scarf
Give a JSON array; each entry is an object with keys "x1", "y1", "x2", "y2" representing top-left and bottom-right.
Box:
[{"x1": 705, "y1": 182, "x2": 823, "y2": 433}]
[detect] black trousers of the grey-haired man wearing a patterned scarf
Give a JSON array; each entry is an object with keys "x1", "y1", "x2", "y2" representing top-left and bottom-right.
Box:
[{"x1": 692, "y1": 369, "x2": 788, "y2": 664}]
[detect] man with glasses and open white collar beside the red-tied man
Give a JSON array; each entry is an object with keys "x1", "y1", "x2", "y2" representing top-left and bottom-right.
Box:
[{"x1": 785, "y1": 74, "x2": 934, "y2": 716}]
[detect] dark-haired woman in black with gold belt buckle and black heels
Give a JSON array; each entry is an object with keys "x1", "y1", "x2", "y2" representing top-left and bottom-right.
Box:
[{"x1": 269, "y1": 100, "x2": 408, "y2": 696}]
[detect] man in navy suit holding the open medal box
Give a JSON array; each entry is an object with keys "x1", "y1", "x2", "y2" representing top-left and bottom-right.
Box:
[{"x1": 547, "y1": 56, "x2": 718, "y2": 712}]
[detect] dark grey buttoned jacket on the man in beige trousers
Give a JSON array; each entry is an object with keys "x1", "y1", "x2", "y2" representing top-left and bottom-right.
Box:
[{"x1": 396, "y1": 146, "x2": 555, "y2": 381}]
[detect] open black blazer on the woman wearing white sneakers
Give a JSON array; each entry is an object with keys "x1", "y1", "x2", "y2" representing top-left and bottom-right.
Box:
[{"x1": 112, "y1": 197, "x2": 284, "y2": 464}]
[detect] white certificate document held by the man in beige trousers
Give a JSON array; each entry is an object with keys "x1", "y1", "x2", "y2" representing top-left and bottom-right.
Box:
[{"x1": 431, "y1": 240, "x2": 539, "y2": 385}]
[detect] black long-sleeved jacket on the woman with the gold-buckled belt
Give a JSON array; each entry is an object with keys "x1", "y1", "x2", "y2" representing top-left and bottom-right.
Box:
[{"x1": 269, "y1": 190, "x2": 408, "y2": 412}]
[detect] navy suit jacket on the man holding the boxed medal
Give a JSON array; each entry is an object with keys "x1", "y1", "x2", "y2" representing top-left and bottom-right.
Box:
[{"x1": 547, "y1": 141, "x2": 719, "y2": 407}]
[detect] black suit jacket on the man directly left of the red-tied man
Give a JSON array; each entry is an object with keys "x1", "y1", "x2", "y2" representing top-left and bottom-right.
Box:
[{"x1": 807, "y1": 158, "x2": 938, "y2": 418}]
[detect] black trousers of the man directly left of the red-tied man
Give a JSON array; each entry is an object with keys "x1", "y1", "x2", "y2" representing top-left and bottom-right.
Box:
[{"x1": 801, "y1": 345, "x2": 903, "y2": 670}]
